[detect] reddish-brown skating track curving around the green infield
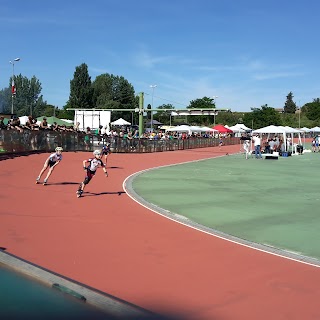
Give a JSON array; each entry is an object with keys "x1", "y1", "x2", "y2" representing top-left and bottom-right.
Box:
[{"x1": 0, "y1": 146, "x2": 320, "y2": 320}]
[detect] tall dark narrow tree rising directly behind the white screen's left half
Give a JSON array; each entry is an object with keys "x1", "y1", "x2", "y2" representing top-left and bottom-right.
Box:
[{"x1": 67, "y1": 63, "x2": 94, "y2": 109}]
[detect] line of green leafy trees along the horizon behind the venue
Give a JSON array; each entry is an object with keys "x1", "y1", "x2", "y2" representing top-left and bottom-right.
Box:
[{"x1": 0, "y1": 63, "x2": 320, "y2": 129}]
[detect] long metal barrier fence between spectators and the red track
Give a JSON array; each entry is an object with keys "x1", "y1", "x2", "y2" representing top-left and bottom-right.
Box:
[{"x1": 0, "y1": 130, "x2": 239, "y2": 153}]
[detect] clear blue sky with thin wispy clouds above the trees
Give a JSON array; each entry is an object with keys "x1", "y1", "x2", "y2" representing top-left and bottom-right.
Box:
[{"x1": 0, "y1": 0, "x2": 320, "y2": 111}]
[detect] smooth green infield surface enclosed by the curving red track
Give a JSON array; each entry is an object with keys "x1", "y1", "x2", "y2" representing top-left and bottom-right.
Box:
[{"x1": 132, "y1": 153, "x2": 320, "y2": 259}]
